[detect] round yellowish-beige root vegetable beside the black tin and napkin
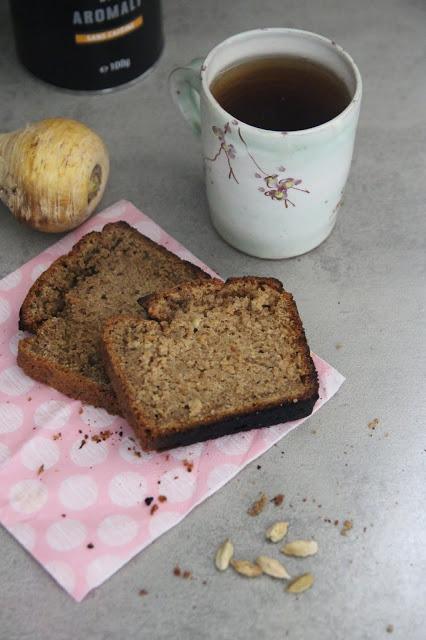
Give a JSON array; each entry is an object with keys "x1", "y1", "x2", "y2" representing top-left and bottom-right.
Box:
[{"x1": 0, "y1": 118, "x2": 109, "y2": 233}]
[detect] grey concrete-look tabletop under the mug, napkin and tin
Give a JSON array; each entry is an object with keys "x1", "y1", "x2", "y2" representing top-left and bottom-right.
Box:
[{"x1": 0, "y1": 0, "x2": 426, "y2": 640}]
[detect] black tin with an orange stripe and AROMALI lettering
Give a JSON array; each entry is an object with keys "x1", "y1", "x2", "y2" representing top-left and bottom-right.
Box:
[{"x1": 10, "y1": 0, "x2": 163, "y2": 91}]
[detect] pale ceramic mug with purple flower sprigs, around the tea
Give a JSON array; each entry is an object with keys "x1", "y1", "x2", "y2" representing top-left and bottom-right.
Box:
[{"x1": 170, "y1": 28, "x2": 362, "y2": 258}]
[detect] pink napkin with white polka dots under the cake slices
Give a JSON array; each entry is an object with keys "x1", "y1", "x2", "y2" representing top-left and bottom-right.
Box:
[{"x1": 0, "y1": 201, "x2": 343, "y2": 601}]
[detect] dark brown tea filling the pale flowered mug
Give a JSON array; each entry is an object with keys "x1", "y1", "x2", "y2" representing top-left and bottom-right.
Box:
[{"x1": 210, "y1": 55, "x2": 352, "y2": 131}]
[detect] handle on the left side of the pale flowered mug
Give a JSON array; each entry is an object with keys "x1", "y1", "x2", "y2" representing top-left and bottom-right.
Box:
[{"x1": 169, "y1": 58, "x2": 204, "y2": 136}]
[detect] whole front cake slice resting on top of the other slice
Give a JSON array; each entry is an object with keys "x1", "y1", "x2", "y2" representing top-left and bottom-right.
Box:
[{"x1": 102, "y1": 277, "x2": 318, "y2": 450}]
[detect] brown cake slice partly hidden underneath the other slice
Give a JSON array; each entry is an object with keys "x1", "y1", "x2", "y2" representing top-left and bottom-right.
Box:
[{"x1": 18, "y1": 221, "x2": 209, "y2": 414}]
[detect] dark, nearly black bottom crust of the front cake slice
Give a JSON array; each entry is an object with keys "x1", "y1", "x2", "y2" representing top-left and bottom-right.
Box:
[{"x1": 146, "y1": 395, "x2": 318, "y2": 451}]
